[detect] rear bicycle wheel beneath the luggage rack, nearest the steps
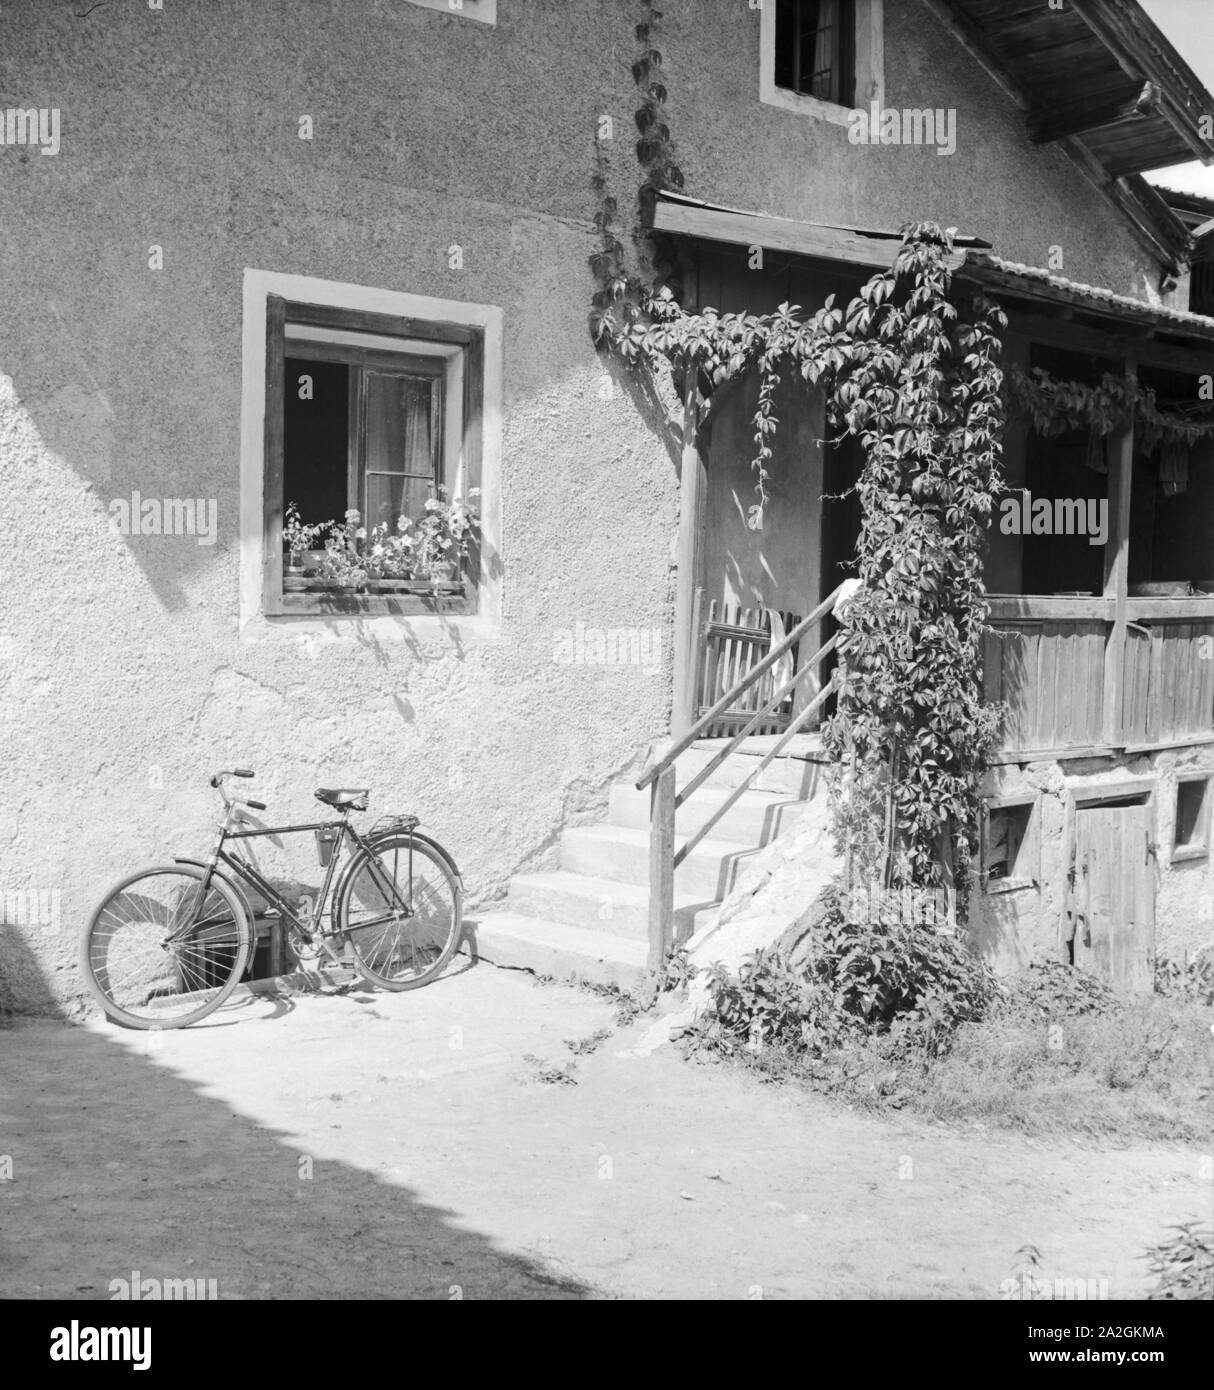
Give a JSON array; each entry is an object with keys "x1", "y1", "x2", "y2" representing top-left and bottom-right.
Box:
[{"x1": 334, "y1": 834, "x2": 463, "y2": 990}]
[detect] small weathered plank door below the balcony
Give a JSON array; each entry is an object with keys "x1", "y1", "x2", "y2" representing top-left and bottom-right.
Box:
[{"x1": 1067, "y1": 802, "x2": 1156, "y2": 994}]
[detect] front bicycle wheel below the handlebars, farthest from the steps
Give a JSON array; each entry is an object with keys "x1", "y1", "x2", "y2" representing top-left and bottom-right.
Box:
[{"x1": 81, "y1": 865, "x2": 253, "y2": 1029}]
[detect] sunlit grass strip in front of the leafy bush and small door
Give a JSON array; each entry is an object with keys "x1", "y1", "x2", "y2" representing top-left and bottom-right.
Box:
[{"x1": 688, "y1": 965, "x2": 1214, "y2": 1143}]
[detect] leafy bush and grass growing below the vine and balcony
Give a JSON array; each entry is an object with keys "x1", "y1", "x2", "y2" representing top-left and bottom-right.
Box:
[{"x1": 684, "y1": 889, "x2": 1214, "y2": 1143}]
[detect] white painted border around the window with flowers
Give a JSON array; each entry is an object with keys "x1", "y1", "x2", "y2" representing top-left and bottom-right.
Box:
[{"x1": 239, "y1": 268, "x2": 502, "y2": 641}]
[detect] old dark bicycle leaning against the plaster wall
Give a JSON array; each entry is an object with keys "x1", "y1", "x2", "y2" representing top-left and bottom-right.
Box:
[{"x1": 81, "y1": 767, "x2": 463, "y2": 1029}]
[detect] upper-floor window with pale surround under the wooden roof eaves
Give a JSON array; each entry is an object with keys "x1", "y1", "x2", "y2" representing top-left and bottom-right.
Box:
[{"x1": 759, "y1": 0, "x2": 884, "y2": 125}]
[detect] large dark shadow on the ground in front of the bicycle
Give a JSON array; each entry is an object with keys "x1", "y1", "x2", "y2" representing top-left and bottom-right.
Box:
[{"x1": 0, "y1": 928, "x2": 591, "y2": 1298}]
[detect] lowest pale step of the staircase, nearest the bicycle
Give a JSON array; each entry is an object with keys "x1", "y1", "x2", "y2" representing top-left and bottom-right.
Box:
[{"x1": 464, "y1": 912, "x2": 648, "y2": 990}]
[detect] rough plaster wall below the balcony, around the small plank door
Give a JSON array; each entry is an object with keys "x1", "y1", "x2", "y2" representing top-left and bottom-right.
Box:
[{"x1": 969, "y1": 748, "x2": 1214, "y2": 970}]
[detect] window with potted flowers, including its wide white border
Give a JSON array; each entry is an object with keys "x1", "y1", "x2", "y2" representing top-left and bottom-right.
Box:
[{"x1": 241, "y1": 270, "x2": 502, "y2": 641}]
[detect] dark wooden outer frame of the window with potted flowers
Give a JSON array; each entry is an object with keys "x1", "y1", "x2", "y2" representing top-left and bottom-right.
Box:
[{"x1": 261, "y1": 301, "x2": 485, "y2": 617}]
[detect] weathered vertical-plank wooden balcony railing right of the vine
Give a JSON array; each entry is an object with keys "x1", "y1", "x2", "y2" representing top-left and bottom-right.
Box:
[{"x1": 983, "y1": 596, "x2": 1214, "y2": 762}]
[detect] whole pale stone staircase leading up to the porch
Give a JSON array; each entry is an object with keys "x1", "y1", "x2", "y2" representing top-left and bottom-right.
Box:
[{"x1": 467, "y1": 735, "x2": 822, "y2": 990}]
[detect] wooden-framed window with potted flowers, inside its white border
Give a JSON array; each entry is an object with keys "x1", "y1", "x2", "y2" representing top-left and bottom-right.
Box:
[{"x1": 263, "y1": 295, "x2": 484, "y2": 614}]
